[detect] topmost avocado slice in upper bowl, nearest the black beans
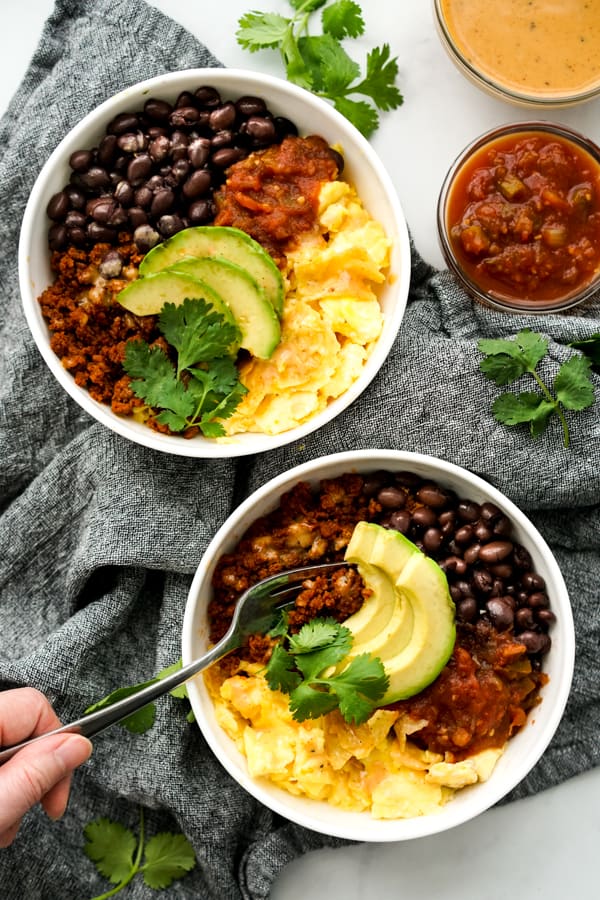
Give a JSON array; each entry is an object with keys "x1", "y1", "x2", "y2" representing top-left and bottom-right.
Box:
[{"x1": 140, "y1": 225, "x2": 283, "y2": 315}]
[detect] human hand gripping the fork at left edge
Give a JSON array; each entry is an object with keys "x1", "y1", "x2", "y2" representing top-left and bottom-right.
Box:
[{"x1": 0, "y1": 688, "x2": 92, "y2": 847}]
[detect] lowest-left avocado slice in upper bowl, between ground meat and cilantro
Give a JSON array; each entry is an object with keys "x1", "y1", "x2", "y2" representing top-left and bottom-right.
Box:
[{"x1": 117, "y1": 272, "x2": 236, "y2": 325}]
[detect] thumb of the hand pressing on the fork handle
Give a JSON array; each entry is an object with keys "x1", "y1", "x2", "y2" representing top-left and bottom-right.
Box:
[{"x1": 0, "y1": 734, "x2": 92, "y2": 833}]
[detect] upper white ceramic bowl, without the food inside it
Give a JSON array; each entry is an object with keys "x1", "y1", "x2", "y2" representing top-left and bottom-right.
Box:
[{"x1": 19, "y1": 68, "x2": 410, "y2": 457}]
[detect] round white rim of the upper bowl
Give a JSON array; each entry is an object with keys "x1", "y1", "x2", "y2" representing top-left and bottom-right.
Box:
[{"x1": 18, "y1": 66, "x2": 412, "y2": 459}]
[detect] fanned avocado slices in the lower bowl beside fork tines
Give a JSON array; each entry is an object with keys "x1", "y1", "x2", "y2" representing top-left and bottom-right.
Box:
[{"x1": 338, "y1": 522, "x2": 456, "y2": 706}]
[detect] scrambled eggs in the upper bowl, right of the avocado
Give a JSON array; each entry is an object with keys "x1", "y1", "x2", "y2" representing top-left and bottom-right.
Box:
[{"x1": 223, "y1": 181, "x2": 390, "y2": 435}]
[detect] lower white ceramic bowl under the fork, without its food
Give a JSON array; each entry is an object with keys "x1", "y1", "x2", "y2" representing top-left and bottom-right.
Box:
[{"x1": 182, "y1": 450, "x2": 575, "y2": 842}]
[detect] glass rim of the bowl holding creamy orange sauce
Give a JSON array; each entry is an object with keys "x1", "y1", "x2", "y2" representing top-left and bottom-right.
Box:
[{"x1": 433, "y1": 0, "x2": 600, "y2": 109}]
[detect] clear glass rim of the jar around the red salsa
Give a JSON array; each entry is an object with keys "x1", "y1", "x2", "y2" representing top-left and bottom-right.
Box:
[{"x1": 436, "y1": 119, "x2": 600, "y2": 315}]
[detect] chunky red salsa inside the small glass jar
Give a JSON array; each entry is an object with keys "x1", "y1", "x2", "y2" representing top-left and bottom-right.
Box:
[{"x1": 445, "y1": 129, "x2": 600, "y2": 308}]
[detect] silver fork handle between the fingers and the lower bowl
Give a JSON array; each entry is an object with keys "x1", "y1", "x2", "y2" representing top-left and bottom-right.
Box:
[{"x1": 0, "y1": 635, "x2": 235, "y2": 765}]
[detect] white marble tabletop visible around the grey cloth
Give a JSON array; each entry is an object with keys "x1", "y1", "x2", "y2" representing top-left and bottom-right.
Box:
[{"x1": 0, "y1": 0, "x2": 600, "y2": 900}]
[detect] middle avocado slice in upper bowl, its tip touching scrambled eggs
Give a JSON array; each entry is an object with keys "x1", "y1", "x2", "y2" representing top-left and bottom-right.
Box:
[{"x1": 170, "y1": 256, "x2": 281, "y2": 359}]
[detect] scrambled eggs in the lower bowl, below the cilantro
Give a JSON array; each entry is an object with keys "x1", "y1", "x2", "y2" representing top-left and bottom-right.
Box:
[{"x1": 204, "y1": 663, "x2": 502, "y2": 819}]
